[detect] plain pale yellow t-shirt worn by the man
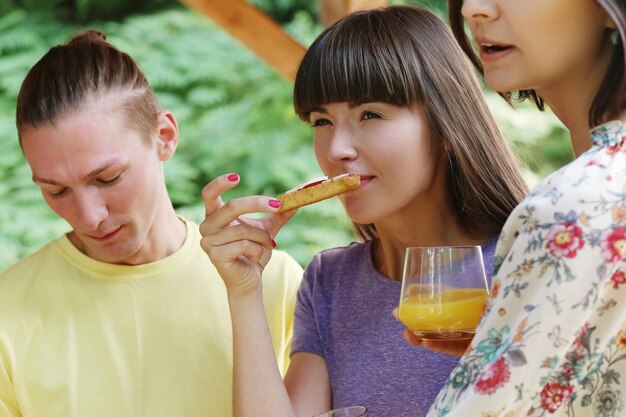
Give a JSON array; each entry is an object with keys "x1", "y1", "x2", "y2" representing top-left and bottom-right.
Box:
[{"x1": 0, "y1": 222, "x2": 302, "y2": 417}]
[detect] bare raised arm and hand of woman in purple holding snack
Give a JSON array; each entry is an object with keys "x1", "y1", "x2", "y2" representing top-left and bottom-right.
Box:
[{"x1": 200, "y1": 176, "x2": 330, "y2": 417}]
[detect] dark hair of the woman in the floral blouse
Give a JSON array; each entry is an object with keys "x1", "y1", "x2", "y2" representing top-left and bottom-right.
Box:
[{"x1": 448, "y1": 0, "x2": 626, "y2": 126}]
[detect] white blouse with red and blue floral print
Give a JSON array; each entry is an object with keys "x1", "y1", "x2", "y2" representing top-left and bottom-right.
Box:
[{"x1": 428, "y1": 121, "x2": 626, "y2": 417}]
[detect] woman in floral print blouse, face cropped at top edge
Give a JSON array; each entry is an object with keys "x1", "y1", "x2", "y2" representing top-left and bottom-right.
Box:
[{"x1": 416, "y1": 0, "x2": 626, "y2": 416}]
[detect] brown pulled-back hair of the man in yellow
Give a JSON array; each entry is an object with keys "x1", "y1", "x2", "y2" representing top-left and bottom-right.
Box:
[{"x1": 16, "y1": 30, "x2": 160, "y2": 143}]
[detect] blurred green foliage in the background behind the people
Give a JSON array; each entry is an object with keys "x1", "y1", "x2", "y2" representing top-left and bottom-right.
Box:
[{"x1": 0, "y1": 0, "x2": 570, "y2": 270}]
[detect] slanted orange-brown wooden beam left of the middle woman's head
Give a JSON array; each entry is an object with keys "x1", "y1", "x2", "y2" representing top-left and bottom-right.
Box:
[{"x1": 180, "y1": 0, "x2": 305, "y2": 81}]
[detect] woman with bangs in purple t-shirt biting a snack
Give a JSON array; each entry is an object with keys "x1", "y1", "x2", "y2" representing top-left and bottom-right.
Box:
[{"x1": 201, "y1": 6, "x2": 527, "y2": 417}]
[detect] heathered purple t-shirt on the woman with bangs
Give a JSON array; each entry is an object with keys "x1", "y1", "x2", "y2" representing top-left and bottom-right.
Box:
[{"x1": 291, "y1": 238, "x2": 497, "y2": 417}]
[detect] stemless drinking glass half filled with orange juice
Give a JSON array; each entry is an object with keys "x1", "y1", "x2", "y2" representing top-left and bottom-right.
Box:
[{"x1": 398, "y1": 246, "x2": 489, "y2": 340}]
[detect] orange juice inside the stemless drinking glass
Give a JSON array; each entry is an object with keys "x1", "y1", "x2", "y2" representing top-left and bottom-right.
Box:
[{"x1": 398, "y1": 288, "x2": 487, "y2": 340}]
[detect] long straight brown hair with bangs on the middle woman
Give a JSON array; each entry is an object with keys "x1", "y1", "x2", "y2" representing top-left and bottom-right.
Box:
[{"x1": 294, "y1": 5, "x2": 528, "y2": 240}]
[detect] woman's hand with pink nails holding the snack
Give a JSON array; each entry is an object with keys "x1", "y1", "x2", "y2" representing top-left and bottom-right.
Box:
[{"x1": 200, "y1": 174, "x2": 295, "y2": 297}]
